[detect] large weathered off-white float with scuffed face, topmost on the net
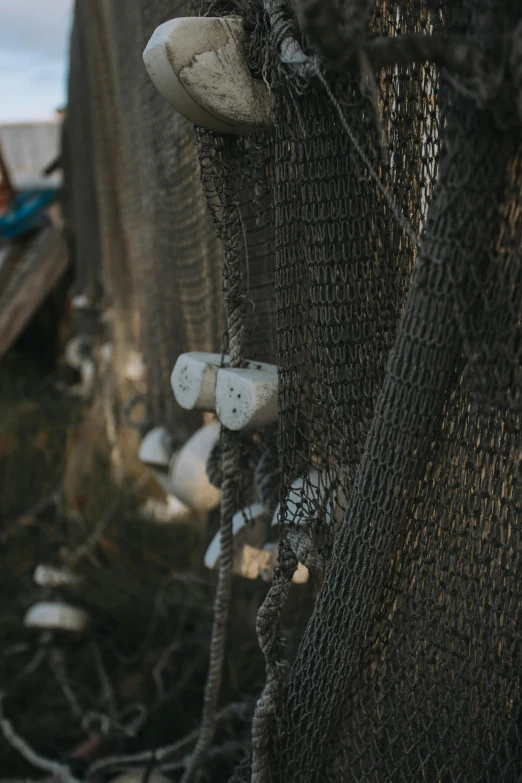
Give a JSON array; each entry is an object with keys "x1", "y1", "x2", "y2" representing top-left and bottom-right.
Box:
[{"x1": 143, "y1": 16, "x2": 275, "y2": 134}]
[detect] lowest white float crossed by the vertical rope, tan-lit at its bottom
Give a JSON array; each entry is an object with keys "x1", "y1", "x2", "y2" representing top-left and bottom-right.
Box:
[{"x1": 205, "y1": 503, "x2": 270, "y2": 579}]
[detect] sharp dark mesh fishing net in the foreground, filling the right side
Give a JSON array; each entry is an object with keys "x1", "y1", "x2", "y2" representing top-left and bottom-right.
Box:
[{"x1": 189, "y1": 2, "x2": 521, "y2": 781}]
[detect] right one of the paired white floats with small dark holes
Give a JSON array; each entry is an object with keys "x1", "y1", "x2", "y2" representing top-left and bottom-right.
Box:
[{"x1": 216, "y1": 361, "x2": 277, "y2": 431}]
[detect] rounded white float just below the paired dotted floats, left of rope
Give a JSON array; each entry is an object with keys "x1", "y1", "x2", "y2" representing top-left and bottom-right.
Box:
[{"x1": 169, "y1": 421, "x2": 221, "y2": 512}]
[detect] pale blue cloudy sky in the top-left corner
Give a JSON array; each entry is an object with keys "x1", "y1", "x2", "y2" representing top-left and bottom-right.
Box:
[{"x1": 0, "y1": 0, "x2": 74, "y2": 123}]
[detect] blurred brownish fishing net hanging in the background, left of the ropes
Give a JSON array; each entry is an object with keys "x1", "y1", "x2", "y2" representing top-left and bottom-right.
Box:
[{"x1": 68, "y1": 2, "x2": 223, "y2": 443}]
